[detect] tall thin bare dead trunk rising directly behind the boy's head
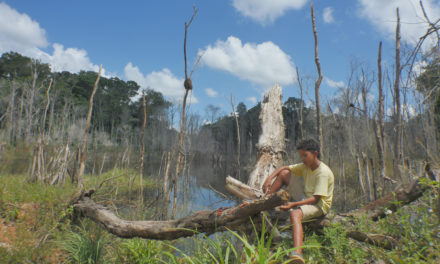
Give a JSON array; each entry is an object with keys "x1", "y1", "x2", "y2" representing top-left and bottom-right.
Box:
[{"x1": 310, "y1": 3, "x2": 324, "y2": 159}]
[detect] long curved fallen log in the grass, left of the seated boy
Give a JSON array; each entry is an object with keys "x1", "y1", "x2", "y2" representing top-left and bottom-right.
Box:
[{"x1": 73, "y1": 190, "x2": 289, "y2": 240}]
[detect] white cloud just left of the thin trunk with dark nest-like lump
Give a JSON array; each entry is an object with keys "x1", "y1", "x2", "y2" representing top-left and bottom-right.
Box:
[{"x1": 124, "y1": 62, "x2": 198, "y2": 103}]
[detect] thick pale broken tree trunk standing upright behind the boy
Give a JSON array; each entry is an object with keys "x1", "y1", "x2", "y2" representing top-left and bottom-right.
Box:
[{"x1": 248, "y1": 84, "x2": 286, "y2": 190}]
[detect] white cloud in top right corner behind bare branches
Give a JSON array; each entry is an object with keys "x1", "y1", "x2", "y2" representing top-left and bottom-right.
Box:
[{"x1": 358, "y1": 0, "x2": 440, "y2": 48}]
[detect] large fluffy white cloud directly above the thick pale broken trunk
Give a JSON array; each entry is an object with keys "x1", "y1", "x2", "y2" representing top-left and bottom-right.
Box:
[{"x1": 199, "y1": 36, "x2": 296, "y2": 89}]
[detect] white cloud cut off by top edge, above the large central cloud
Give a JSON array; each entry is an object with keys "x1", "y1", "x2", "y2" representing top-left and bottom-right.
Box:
[{"x1": 232, "y1": 0, "x2": 307, "y2": 24}]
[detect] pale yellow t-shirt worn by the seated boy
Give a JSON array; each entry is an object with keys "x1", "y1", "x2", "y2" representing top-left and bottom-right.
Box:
[{"x1": 289, "y1": 161, "x2": 334, "y2": 214}]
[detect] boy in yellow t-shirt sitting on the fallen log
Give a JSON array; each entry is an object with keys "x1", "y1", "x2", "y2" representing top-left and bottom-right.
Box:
[{"x1": 263, "y1": 139, "x2": 334, "y2": 263}]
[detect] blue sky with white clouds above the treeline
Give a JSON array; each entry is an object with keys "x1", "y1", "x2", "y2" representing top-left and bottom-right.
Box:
[{"x1": 0, "y1": 0, "x2": 440, "y2": 115}]
